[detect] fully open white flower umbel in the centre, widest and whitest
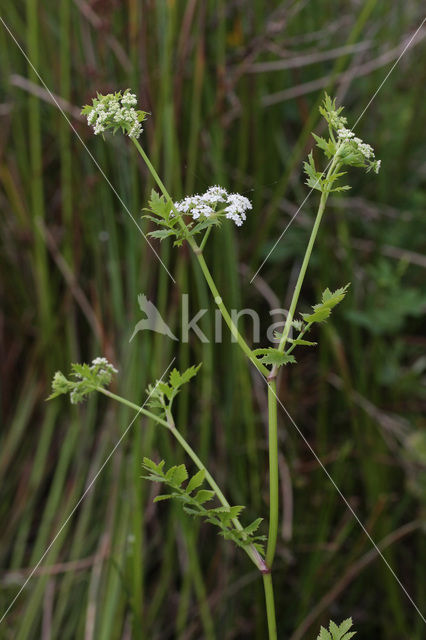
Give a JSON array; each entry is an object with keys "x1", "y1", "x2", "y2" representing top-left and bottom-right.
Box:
[{"x1": 174, "y1": 185, "x2": 252, "y2": 227}]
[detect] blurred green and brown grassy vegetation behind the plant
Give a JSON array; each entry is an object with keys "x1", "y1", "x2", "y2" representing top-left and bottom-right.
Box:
[{"x1": 0, "y1": 0, "x2": 426, "y2": 640}]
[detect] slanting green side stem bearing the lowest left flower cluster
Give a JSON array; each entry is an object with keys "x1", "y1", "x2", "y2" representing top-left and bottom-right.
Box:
[{"x1": 97, "y1": 387, "x2": 267, "y2": 573}]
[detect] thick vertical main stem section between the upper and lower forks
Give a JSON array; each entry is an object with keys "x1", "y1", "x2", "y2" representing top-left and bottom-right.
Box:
[{"x1": 265, "y1": 380, "x2": 278, "y2": 568}]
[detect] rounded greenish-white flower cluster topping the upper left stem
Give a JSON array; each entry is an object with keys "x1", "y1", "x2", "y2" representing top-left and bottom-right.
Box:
[{"x1": 82, "y1": 89, "x2": 146, "y2": 138}]
